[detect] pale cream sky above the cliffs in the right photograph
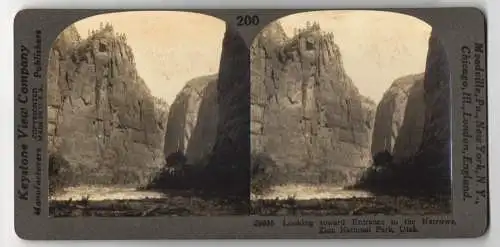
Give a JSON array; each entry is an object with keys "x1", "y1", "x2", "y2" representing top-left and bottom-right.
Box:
[{"x1": 279, "y1": 10, "x2": 431, "y2": 102}]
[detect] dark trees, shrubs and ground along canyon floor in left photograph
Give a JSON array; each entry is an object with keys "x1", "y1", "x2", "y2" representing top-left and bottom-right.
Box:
[{"x1": 49, "y1": 149, "x2": 249, "y2": 217}]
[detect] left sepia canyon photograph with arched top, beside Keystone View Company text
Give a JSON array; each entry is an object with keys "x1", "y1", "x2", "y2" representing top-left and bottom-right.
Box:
[{"x1": 47, "y1": 11, "x2": 250, "y2": 217}]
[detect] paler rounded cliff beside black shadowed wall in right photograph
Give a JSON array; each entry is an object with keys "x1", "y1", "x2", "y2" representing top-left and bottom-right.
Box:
[{"x1": 371, "y1": 73, "x2": 425, "y2": 162}]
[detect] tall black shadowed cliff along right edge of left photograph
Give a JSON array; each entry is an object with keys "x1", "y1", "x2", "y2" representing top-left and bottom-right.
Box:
[{"x1": 208, "y1": 25, "x2": 250, "y2": 196}]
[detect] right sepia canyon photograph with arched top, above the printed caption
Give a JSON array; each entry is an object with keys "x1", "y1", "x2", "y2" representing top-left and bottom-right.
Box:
[{"x1": 250, "y1": 10, "x2": 451, "y2": 216}]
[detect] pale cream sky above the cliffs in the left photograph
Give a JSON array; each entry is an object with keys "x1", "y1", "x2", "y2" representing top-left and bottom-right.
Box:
[{"x1": 75, "y1": 11, "x2": 226, "y2": 104}]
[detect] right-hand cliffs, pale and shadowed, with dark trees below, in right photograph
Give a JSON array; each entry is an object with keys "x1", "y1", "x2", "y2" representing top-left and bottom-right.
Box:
[{"x1": 360, "y1": 30, "x2": 451, "y2": 196}]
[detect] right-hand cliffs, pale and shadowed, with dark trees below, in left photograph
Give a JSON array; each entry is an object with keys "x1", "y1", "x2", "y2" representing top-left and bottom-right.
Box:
[{"x1": 148, "y1": 26, "x2": 250, "y2": 201}]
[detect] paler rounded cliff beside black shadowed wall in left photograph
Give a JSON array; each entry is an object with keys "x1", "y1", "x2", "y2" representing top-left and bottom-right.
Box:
[{"x1": 164, "y1": 75, "x2": 218, "y2": 165}]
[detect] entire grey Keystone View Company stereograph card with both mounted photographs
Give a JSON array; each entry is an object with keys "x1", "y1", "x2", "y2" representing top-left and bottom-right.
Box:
[{"x1": 10, "y1": 6, "x2": 490, "y2": 241}]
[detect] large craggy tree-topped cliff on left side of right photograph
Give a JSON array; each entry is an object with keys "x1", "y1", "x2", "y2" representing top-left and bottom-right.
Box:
[{"x1": 251, "y1": 23, "x2": 375, "y2": 185}]
